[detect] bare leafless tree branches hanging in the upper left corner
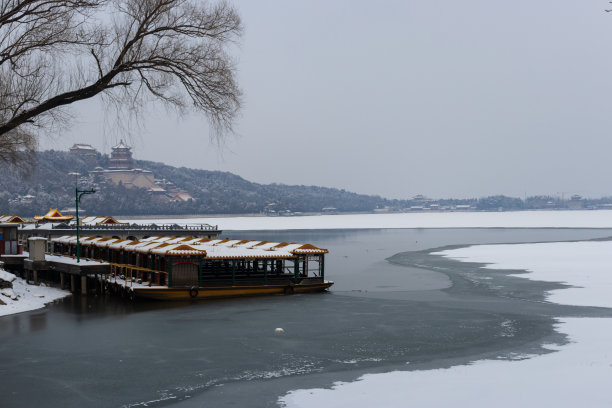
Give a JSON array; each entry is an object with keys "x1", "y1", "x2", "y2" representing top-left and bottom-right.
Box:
[{"x1": 0, "y1": 0, "x2": 242, "y2": 163}]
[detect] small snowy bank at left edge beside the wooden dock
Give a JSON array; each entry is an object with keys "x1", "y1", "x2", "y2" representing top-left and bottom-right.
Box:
[{"x1": 0, "y1": 269, "x2": 70, "y2": 316}]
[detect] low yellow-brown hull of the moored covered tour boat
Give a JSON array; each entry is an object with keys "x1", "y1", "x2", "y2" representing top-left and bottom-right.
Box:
[{"x1": 132, "y1": 281, "x2": 334, "y2": 300}]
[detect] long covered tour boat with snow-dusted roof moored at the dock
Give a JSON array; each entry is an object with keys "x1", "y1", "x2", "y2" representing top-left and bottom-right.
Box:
[{"x1": 51, "y1": 235, "x2": 333, "y2": 300}]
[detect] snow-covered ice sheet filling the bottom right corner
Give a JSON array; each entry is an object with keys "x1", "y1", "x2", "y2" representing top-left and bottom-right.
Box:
[{"x1": 280, "y1": 318, "x2": 612, "y2": 408}]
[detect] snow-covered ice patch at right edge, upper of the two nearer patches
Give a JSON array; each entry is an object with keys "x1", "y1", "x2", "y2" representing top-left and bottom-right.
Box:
[{"x1": 437, "y1": 241, "x2": 612, "y2": 307}]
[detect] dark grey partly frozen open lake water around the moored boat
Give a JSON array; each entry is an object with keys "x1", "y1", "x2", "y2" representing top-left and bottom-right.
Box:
[{"x1": 0, "y1": 229, "x2": 612, "y2": 407}]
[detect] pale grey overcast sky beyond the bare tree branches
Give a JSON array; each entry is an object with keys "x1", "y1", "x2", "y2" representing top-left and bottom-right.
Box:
[{"x1": 41, "y1": 0, "x2": 612, "y2": 199}]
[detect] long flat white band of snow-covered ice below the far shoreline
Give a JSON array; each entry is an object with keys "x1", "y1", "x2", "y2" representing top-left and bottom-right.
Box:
[{"x1": 128, "y1": 210, "x2": 612, "y2": 230}]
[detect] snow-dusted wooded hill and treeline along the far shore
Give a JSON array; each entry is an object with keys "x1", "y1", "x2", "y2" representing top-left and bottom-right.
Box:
[{"x1": 0, "y1": 150, "x2": 612, "y2": 216}]
